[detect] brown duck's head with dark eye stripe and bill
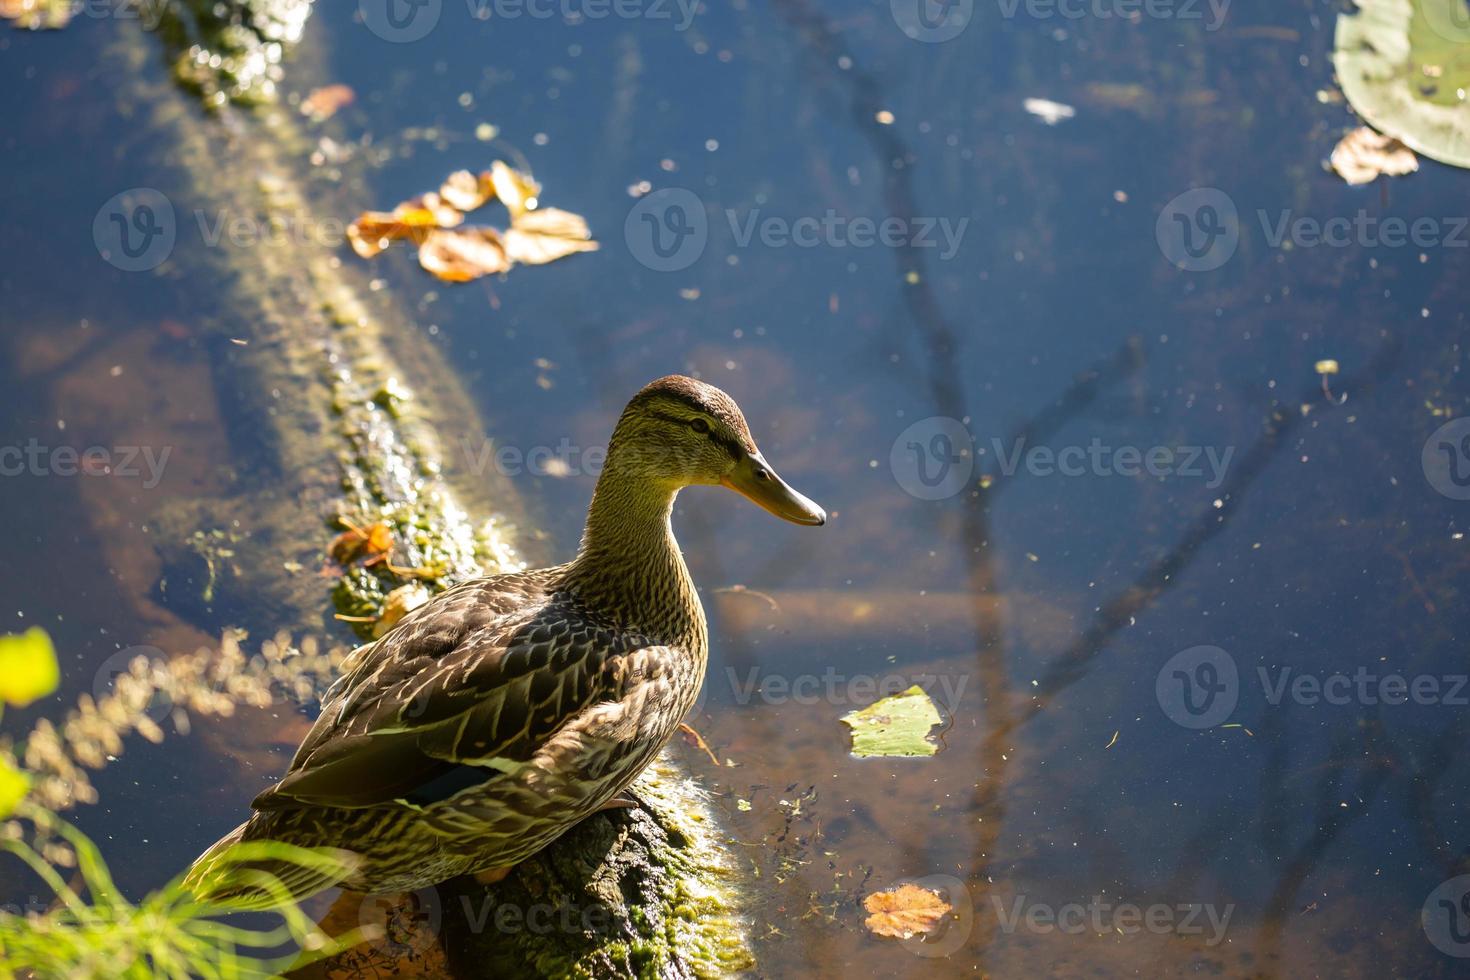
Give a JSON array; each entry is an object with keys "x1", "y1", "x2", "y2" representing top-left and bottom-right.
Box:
[{"x1": 607, "y1": 375, "x2": 826, "y2": 525}]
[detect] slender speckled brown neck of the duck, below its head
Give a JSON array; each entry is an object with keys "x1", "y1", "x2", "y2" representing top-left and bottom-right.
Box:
[{"x1": 566, "y1": 455, "x2": 707, "y2": 652}]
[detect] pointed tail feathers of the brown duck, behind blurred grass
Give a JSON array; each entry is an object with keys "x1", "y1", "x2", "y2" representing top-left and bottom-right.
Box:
[{"x1": 182, "y1": 814, "x2": 360, "y2": 912}]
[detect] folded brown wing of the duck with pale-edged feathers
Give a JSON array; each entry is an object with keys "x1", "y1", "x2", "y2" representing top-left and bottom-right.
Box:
[{"x1": 253, "y1": 573, "x2": 637, "y2": 810}]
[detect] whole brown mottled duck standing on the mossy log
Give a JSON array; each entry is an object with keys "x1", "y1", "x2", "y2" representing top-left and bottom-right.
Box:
[{"x1": 190, "y1": 376, "x2": 826, "y2": 907}]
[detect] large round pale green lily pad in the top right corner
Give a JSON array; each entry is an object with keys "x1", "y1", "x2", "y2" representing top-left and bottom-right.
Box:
[{"x1": 1332, "y1": 0, "x2": 1470, "y2": 167}]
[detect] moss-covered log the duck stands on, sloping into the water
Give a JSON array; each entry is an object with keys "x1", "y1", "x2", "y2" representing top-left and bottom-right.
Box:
[{"x1": 110, "y1": 0, "x2": 750, "y2": 977}]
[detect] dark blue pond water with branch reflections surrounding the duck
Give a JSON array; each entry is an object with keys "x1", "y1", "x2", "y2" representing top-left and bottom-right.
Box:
[{"x1": 0, "y1": 0, "x2": 1470, "y2": 977}]
